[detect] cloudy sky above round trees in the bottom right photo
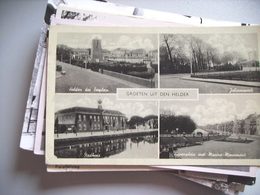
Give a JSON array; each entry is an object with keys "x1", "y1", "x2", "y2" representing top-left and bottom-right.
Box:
[{"x1": 160, "y1": 94, "x2": 260, "y2": 126}]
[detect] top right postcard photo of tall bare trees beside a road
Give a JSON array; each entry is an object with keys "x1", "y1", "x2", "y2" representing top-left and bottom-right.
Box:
[{"x1": 159, "y1": 29, "x2": 260, "y2": 94}]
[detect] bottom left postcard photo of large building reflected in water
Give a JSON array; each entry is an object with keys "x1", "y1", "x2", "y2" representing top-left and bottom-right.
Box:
[{"x1": 52, "y1": 94, "x2": 158, "y2": 159}]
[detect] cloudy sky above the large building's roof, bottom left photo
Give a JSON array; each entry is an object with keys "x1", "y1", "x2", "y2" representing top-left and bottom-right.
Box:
[{"x1": 55, "y1": 94, "x2": 158, "y2": 119}]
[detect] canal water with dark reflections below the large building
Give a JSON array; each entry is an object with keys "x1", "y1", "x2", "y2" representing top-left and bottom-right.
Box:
[{"x1": 55, "y1": 135, "x2": 158, "y2": 159}]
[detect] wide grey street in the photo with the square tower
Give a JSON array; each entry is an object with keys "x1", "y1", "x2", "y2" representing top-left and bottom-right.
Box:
[{"x1": 56, "y1": 63, "x2": 143, "y2": 93}]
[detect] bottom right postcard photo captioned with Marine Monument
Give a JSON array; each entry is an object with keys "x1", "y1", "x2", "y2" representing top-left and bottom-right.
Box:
[{"x1": 160, "y1": 94, "x2": 260, "y2": 159}]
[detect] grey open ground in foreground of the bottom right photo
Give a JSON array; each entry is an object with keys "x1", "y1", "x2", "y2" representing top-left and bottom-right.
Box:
[{"x1": 176, "y1": 135, "x2": 260, "y2": 159}]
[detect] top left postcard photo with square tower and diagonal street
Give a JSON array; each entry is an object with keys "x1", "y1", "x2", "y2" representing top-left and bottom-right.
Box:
[{"x1": 51, "y1": 31, "x2": 158, "y2": 93}]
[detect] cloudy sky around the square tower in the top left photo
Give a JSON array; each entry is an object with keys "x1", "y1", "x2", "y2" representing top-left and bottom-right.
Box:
[{"x1": 57, "y1": 33, "x2": 158, "y2": 51}]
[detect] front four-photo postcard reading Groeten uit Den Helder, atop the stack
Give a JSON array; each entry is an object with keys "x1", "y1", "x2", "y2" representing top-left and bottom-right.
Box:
[{"x1": 46, "y1": 25, "x2": 260, "y2": 165}]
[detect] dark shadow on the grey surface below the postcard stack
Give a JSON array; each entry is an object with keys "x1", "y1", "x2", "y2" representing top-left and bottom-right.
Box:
[{"x1": 14, "y1": 150, "x2": 222, "y2": 194}]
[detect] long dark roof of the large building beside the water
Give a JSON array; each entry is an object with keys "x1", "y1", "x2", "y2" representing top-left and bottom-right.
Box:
[{"x1": 56, "y1": 107, "x2": 125, "y2": 116}]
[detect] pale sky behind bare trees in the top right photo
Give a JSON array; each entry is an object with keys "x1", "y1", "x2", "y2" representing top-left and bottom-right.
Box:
[{"x1": 160, "y1": 33, "x2": 258, "y2": 60}]
